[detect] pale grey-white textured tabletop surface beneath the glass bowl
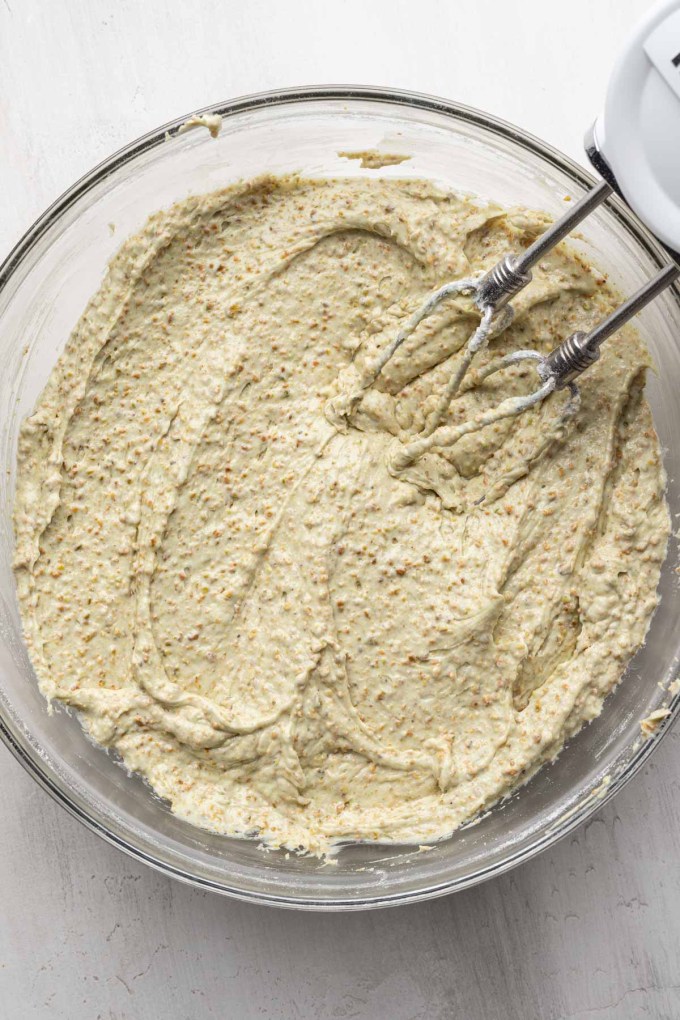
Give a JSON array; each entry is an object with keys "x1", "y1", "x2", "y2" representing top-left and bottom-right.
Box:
[{"x1": 0, "y1": 0, "x2": 680, "y2": 1020}]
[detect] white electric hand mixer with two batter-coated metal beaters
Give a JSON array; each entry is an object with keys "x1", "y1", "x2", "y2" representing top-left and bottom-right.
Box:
[{"x1": 355, "y1": 0, "x2": 680, "y2": 470}]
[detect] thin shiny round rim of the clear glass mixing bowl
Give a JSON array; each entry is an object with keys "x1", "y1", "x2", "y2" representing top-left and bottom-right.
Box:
[{"x1": 0, "y1": 85, "x2": 680, "y2": 911}]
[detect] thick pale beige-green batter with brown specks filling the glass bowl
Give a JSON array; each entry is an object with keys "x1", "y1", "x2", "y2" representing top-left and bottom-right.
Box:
[{"x1": 15, "y1": 177, "x2": 669, "y2": 853}]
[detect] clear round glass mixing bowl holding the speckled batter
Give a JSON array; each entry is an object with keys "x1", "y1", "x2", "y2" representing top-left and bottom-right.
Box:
[{"x1": 0, "y1": 87, "x2": 680, "y2": 909}]
